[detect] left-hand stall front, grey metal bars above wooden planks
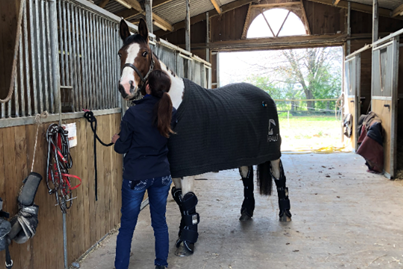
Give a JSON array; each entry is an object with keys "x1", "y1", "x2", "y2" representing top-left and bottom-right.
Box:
[{"x1": 0, "y1": 0, "x2": 211, "y2": 269}]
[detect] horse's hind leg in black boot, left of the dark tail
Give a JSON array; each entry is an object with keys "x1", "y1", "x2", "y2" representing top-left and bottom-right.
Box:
[{"x1": 239, "y1": 166, "x2": 255, "y2": 221}]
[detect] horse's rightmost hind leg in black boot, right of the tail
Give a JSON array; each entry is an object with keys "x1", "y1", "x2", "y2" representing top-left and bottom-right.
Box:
[{"x1": 271, "y1": 159, "x2": 292, "y2": 221}]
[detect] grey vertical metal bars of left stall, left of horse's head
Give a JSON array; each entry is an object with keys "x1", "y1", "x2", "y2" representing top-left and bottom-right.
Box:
[{"x1": 0, "y1": 0, "x2": 123, "y2": 127}]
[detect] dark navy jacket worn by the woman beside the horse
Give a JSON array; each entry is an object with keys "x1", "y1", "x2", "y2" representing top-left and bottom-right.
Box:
[{"x1": 114, "y1": 95, "x2": 176, "y2": 181}]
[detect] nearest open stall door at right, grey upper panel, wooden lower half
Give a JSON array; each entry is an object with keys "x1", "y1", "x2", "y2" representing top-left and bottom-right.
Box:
[{"x1": 371, "y1": 37, "x2": 399, "y2": 178}]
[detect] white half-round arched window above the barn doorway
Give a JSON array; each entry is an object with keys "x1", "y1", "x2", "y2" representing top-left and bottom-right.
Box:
[{"x1": 246, "y1": 8, "x2": 307, "y2": 38}]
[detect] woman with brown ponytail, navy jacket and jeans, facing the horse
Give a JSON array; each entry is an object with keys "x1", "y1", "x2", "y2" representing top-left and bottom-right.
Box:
[{"x1": 112, "y1": 70, "x2": 176, "y2": 269}]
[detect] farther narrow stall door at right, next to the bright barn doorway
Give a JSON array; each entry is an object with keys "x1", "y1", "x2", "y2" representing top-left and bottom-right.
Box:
[{"x1": 345, "y1": 54, "x2": 361, "y2": 150}]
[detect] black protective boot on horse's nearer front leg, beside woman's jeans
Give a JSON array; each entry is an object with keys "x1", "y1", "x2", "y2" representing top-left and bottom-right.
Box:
[{"x1": 175, "y1": 192, "x2": 200, "y2": 257}]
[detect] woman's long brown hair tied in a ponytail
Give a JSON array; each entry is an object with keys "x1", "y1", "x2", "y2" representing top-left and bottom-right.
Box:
[{"x1": 148, "y1": 70, "x2": 174, "y2": 138}]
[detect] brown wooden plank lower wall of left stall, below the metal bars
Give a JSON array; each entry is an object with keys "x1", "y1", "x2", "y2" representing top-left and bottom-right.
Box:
[{"x1": 0, "y1": 113, "x2": 123, "y2": 269}]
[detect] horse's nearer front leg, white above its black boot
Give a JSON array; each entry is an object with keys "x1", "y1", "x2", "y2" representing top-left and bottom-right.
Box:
[{"x1": 172, "y1": 177, "x2": 200, "y2": 257}]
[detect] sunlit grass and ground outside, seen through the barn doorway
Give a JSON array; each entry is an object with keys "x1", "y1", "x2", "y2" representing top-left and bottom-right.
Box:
[{"x1": 279, "y1": 112, "x2": 351, "y2": 153}]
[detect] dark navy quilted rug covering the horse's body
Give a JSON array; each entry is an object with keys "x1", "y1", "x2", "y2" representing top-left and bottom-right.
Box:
[{"x1": 168, "y1": 79, "x2": 281, "y2": 178}]
